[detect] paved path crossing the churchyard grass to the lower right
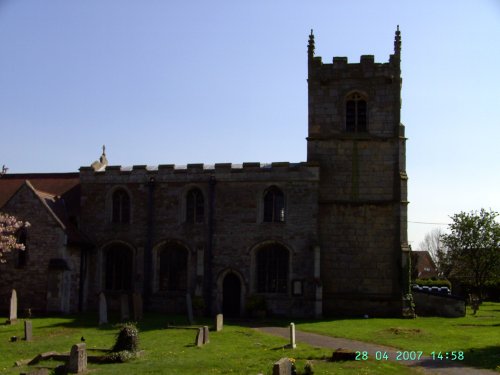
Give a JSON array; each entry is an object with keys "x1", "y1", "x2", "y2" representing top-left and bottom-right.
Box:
[{"x1": 255, "y1": 327, "x2": 498, "y2": 375}]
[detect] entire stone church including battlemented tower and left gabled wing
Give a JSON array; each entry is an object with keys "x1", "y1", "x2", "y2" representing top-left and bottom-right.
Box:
[{"x1": 0, "y1": 30, "x2": 408, "y2": 316}]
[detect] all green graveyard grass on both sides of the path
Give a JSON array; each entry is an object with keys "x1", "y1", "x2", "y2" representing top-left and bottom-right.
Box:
[{"x1": 0, "y1": 303, "x2": 500, "y2": 375}]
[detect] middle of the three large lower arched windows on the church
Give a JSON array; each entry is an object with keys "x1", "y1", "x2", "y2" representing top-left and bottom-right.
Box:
[{"x1": 158, "y1": 244, "x2": 188, "y2": 291}]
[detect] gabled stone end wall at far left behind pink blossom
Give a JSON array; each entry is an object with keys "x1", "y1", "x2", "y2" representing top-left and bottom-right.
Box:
[{"x1": 0, "y1": 185, "x2": 80, "y2": 316}]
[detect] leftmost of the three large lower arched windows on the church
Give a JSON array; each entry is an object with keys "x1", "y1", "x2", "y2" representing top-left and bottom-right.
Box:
[{"x1": 105, "y1": 244, "x2": 132, "y2": 290}]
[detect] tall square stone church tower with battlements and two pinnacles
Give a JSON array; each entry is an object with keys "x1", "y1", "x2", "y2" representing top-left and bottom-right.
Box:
[{"x1": 307, "y1": 27, "x2": 409, "y2": 315}]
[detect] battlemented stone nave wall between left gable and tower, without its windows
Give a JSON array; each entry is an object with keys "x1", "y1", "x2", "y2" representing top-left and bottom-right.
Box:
[{"x1": 81, "y1": 163, "x2": 319, "y2": 316}]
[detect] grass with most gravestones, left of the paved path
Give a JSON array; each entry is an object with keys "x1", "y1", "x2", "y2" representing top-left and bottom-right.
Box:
[{"x1": 0, "y1": 314, "x2": 417, "y2": 375}]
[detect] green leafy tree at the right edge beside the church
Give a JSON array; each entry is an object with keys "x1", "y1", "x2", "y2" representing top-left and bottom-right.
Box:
[{"x1": 441, "y1": 209, "x2": 500, "y2": 298}]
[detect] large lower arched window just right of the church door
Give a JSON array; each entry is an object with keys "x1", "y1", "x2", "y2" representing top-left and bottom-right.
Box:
[{"x1": 255, "y1": 244, "x2": 289, "y2": 293}]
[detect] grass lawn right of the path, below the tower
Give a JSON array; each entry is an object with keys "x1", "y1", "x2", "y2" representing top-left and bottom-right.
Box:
[{"x1": 296, "y1": 302, "x2": 500, "y2": 372}]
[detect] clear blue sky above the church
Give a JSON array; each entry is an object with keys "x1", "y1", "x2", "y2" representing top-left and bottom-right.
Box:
[{"x1": 0, "y1": 0, "x2": 500, "y2": 249}]
